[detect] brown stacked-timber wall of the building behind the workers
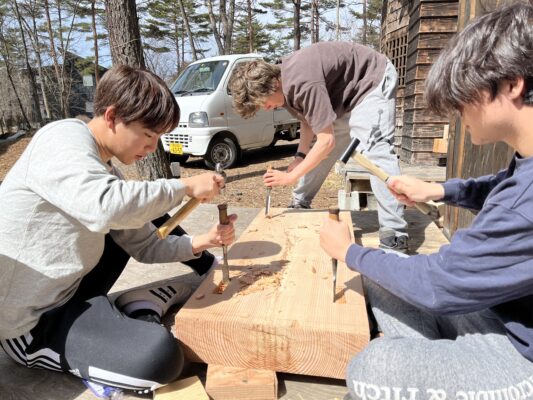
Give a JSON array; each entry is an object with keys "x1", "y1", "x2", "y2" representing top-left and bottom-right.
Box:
[{"x1": 400, "y1": 0, "x2": 458, "y2": 165}]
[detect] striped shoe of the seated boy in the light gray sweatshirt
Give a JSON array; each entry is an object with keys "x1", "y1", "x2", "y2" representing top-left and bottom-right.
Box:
[{"x1": 115, "y1": 281, "x2": 192, "y2": 316}]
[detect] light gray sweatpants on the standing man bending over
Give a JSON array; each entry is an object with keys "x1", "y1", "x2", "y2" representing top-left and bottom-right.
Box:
[{"x1": 293, "y1": 61, "x2": 407, "y2": 236}]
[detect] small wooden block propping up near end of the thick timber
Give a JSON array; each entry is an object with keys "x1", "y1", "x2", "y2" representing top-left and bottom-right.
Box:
[{"x1": 205, "y1": 364, "x2": 278, "y2": 400}]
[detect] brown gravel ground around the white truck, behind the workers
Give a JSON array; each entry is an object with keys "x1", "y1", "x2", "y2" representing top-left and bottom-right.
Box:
[{"x1": 0, "y1": 137, "x2": 342, "y2": 208}]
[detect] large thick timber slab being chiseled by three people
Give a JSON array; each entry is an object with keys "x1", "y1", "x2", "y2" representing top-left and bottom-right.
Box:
[{"x1": 175, "y1": 208, "x2": 369, "y2": 379}]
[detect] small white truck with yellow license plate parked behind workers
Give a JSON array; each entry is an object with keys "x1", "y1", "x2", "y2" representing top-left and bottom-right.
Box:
[{"x1": 161, "y1": 54, "x2": 300, "y2": 169}]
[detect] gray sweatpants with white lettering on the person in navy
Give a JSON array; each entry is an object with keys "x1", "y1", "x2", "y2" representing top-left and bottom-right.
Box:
[{"x1": 347, "y1": 279, "x2": 533, "y2": 400}]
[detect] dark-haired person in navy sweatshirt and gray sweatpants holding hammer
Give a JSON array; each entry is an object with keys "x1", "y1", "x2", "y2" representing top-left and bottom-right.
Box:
[{"x1": 320, "y1": 3, "x2": 533, "y2": 400}]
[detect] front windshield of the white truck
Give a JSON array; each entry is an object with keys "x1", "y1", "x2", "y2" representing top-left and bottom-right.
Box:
[{"x1": 172, "y1": 60, "x2": 228, "y2": 96}]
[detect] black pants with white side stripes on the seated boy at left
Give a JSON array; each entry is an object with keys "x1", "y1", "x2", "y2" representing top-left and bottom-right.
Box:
[{"x1": 0, "y1": 217, "x2": 214, "y2": 391}]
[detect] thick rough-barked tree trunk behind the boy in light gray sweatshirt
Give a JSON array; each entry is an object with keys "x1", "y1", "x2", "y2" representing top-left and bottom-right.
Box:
[{"x1": 105, "y1": 0, "x2": 172, "y2": 180}]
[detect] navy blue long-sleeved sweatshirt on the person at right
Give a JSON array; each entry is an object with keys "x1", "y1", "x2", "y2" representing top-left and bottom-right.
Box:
[{"x1": 346, "y1": 157, "x2": 533, "y2": 361}]
